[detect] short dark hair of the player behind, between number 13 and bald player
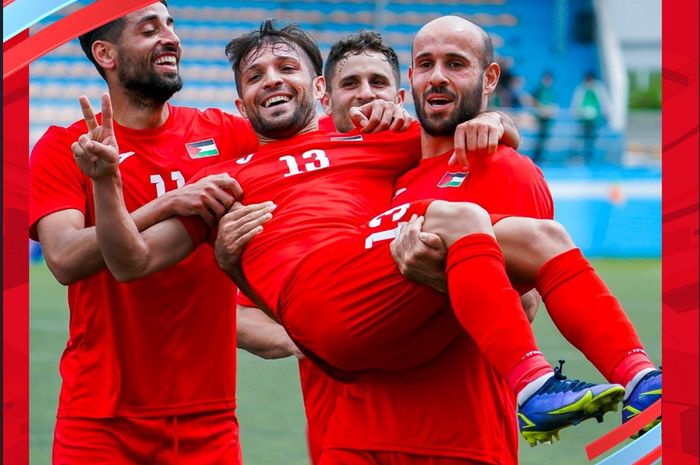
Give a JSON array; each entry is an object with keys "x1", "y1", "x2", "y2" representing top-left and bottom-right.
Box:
[{"x1": 323, "y1": 31, "x2": 401, "y2": 90}]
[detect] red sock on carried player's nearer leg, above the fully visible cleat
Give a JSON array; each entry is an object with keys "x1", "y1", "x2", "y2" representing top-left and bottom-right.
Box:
[{"x1": 447, "y1": 234, "x2": 552, "y2": 394}]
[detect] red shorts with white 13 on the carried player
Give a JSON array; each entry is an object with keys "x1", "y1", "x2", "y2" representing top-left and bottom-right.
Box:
[{"x1": 279, "y1": 200, "x2": 462, "y2": 377}]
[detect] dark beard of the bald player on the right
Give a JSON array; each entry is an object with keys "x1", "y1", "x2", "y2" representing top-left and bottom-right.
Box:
[{"x1": 413, "y1": 79, "x2": 483, "y2": 136}]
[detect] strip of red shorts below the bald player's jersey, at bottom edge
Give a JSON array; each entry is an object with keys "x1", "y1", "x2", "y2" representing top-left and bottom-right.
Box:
[{"x1": 318, "y1": 449, "x2": 493, "y2": 465}]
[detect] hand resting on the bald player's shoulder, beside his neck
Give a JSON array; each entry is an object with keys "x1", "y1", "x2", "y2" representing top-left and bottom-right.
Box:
[{"x1": 449, "y1": 111, "x2": 505, "y2": 166}]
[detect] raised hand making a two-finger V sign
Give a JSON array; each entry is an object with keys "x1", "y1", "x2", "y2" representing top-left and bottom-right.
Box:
[{"x1": 71, "y1": 93, "x2": 119, "y2": 180}]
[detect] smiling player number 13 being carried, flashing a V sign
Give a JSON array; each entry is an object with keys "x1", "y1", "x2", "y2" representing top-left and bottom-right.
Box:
[{"x1": 74, "y1": 21, "x2": 660, "y2": 440}]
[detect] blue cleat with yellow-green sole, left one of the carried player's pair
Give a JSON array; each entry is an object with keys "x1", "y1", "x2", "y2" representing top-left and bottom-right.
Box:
[{"x1": 518, "y1": 360, "x2": 625, "y2": 446}]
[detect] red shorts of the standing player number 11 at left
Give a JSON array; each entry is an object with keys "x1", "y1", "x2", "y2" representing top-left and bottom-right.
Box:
[{"x1": 53, "y1": 411, "x2": 243, "y2": 465}]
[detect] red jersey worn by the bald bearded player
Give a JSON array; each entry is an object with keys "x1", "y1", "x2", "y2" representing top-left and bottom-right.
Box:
[{"x1": 326, "y1": 146, "x2": 553, "y2": 465}]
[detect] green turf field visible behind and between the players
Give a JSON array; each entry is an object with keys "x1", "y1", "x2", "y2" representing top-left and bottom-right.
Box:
[{"x1": 30, "y1": 260, "x2": 661, "y2": 465}]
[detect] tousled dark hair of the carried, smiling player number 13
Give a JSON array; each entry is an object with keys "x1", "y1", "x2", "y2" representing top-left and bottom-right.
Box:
[{"x1": 226, "y1": 19, "x2": 323, "y2": 95}]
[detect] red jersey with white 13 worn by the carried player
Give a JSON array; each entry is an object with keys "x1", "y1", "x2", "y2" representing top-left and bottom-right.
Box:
[{"x1": 183, "y1": 127, "x2": 420, "y2": 316}]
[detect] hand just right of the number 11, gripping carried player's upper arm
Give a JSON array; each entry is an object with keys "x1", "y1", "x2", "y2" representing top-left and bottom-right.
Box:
[{"x1": 159, "y1": 173, "x2": 243, "y2": 228}]
